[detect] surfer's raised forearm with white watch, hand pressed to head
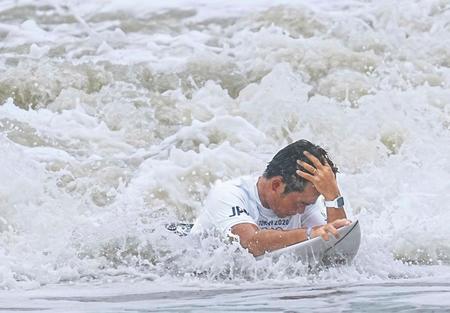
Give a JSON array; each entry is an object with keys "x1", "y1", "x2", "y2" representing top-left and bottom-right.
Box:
[{"x1": 297, "y1": 151, "x2": 347, "y2": 223}]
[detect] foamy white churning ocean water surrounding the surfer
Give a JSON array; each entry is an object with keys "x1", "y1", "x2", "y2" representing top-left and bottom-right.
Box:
[{"x1": 0, "y1": 0, "x2": 450, "y2": 312}]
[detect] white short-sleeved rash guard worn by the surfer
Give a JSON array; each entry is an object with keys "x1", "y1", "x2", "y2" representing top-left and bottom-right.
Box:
[{"x1": 191, "y1": 176, "x2": 326, "y2": 236}]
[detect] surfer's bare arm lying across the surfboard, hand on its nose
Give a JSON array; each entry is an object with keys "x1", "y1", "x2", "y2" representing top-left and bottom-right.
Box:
[{"x1": 231, "y1": 219, "x2": 349, "y2": 256}]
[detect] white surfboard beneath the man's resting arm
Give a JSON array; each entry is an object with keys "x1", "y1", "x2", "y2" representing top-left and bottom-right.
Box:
[{"x1": 256, "y1": 221, "x2": 361, "y2": 266}]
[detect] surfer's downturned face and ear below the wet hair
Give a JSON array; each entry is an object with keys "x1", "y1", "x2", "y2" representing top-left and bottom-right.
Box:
[{"x1": 271, "y1": 183, "x2": 320, "y2": 217}]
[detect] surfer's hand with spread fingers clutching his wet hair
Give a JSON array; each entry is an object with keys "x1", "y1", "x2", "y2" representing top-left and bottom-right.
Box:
[{"x1": 296, "y1": 151, "x2": 340, "y2": 201}]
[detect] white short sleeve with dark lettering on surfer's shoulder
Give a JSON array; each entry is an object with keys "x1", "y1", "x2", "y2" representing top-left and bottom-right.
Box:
[{"x1": 204, "y1": 185, "x2": 256, "y2": 235}]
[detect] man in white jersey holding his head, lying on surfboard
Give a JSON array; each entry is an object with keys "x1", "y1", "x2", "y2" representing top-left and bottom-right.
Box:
[{"x1": 191, "y1": 140, "x2": 350, "y2": 256}]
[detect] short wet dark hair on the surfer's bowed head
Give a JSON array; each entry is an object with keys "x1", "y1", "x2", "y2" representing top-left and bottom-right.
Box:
[{"x1": 263, "y1": 139, "x2": 338, "y2": 194}]
